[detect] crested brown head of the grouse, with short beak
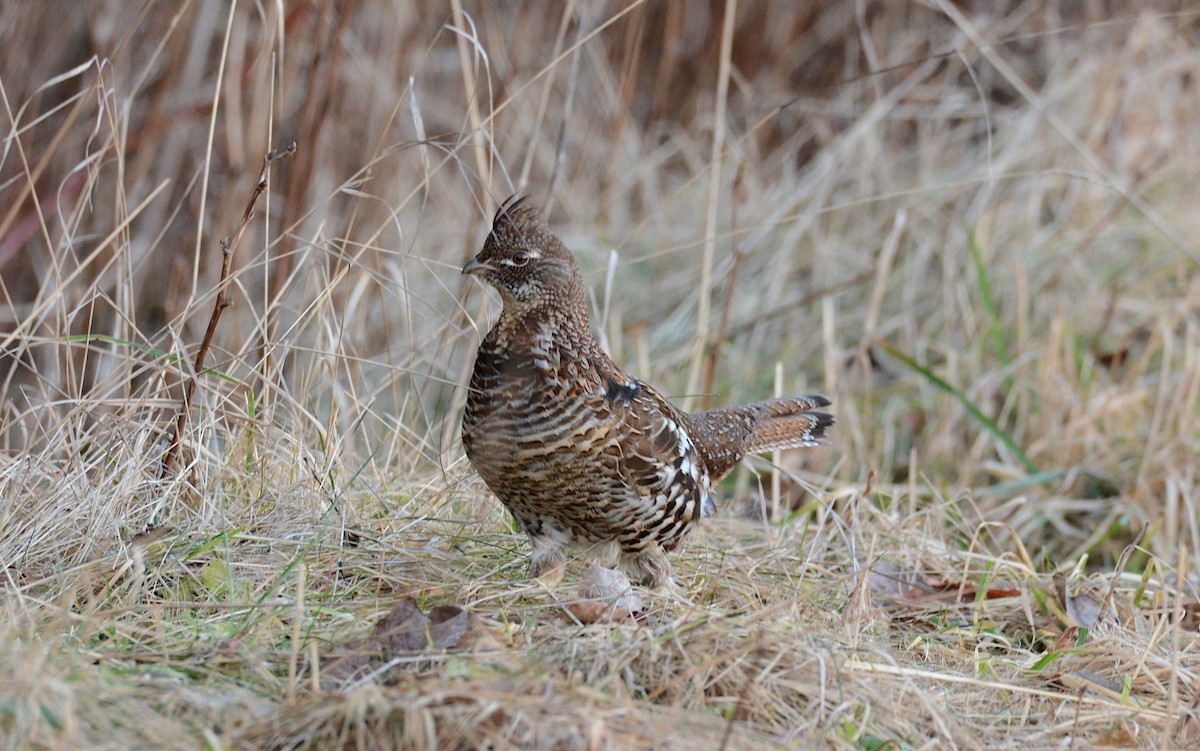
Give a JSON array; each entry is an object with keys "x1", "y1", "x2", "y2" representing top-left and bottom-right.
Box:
[{"x1": 462, "y1": 197, "x2": 582, "y2": 311}]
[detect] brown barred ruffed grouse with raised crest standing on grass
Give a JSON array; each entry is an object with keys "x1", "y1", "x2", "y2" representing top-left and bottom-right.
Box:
[{"x1": 462, "y1": 199, "x2": 833, "y2": 587}]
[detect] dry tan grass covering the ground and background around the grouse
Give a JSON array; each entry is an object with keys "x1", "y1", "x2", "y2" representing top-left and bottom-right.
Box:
[{"x1": 0, "y1": 0, "x2": 1200, "y2": 750}]
